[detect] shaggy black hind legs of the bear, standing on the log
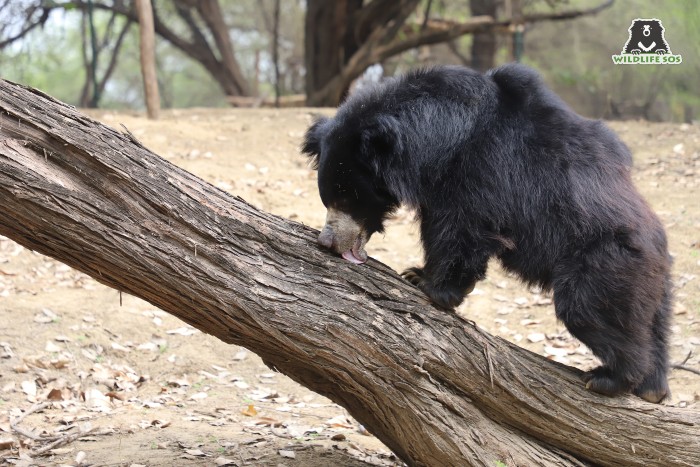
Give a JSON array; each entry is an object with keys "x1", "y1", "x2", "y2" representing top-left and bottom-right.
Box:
[{"x1": 553, "y1": 250, "x2": 666, "y2": 400}]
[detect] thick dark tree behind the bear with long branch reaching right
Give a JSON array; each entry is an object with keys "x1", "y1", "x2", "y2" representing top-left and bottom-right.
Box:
[{"x1": 305, "y1": 0, "x2": 613, "y2": 106}]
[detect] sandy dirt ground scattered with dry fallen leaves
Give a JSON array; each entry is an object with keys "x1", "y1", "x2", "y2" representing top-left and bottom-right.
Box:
[{"x1": 0, "y1": 109, "x2": 700, "y2": 466}]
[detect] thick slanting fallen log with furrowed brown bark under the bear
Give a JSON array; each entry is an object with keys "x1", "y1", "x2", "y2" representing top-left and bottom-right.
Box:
[{"x1": 0, "y1": 80, "x2": 700, "y2": 466}]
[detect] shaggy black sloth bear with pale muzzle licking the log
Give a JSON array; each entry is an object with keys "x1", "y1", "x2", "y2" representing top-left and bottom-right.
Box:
[{"x1": 302, "y1": 64, "x2": 671, "y2": 402}]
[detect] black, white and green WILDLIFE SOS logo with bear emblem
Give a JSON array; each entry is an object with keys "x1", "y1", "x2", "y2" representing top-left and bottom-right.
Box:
[{"x1": 612, "y1": 18, "x2": 683, "y2": 65}]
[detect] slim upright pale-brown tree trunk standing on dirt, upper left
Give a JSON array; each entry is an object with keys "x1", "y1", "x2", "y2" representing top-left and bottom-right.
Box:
[{"x1": 136, "y1": 0, "x2": 160, "y2": 120}]
